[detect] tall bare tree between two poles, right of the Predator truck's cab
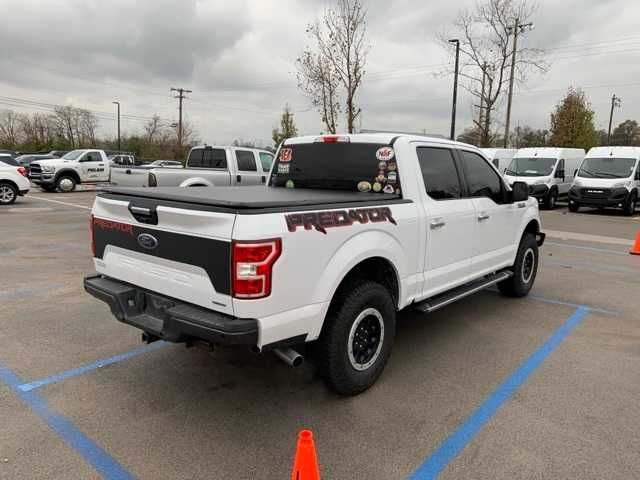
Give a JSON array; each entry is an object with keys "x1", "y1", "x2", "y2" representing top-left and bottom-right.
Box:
[{"x1": 438, "y1": 0, "x2": 548, "y2": 146}]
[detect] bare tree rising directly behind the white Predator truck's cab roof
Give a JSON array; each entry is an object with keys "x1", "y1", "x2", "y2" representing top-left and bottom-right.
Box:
[{"x1": 298, "y1": 0, "x2": 369, "y2": 133}]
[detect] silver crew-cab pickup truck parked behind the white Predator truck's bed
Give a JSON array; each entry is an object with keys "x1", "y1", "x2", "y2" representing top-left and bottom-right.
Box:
[{"x1": 111, "y1": 145, "x2": 273, "y2": 187}]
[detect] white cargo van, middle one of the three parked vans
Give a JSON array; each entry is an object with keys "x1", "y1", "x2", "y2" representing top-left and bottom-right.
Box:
[{"x1": 504, "y1": 147, "x2": 584, "y2": 210}]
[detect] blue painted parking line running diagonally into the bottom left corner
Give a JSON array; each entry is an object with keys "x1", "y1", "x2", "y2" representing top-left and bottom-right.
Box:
[{"x1": 0, "y1": 363, "x2": 135, "y2": 480}]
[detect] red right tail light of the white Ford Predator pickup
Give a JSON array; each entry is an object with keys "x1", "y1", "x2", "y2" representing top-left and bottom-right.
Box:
[{"x1": 231, "y1": 238, "x2": 282, "y2": 299}]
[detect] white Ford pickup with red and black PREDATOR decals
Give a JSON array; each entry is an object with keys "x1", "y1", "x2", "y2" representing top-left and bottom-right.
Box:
[{"x1": 84, "y1": 134, "x2": 544, "y2": 395}]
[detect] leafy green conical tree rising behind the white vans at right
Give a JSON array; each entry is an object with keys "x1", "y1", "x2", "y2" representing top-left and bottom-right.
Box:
[{"x1": 549, "y1": 87, "x2": 599, "y2": 150}]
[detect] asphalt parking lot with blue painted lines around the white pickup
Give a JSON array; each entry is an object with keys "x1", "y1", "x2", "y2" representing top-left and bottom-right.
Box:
[{"x1": 0, "y1": 192, "x2": 640, "y2": 479}]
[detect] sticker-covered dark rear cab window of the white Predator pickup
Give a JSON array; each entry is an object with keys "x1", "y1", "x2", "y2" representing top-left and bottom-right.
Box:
[{"x1": 269, "y1": 142, "x2": 401, "y2": 195}]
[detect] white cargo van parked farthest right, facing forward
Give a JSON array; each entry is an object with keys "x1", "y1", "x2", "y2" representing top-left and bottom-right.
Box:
[{"x1": 569, "y1": 147, "x2": 640, "y2": 215}]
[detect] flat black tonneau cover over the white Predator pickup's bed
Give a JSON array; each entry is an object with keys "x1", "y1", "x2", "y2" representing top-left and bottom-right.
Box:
[{"x1": 101, "y1": 186, "x2": 403, "y2": 210}]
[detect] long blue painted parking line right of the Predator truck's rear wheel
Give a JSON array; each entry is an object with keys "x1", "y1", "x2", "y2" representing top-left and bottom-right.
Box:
[{"x1": 410, "y1": 306, "x2": 591, "y2": 480}]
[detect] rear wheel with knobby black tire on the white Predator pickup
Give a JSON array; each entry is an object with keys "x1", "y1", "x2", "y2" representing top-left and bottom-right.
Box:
[{"x1": 316, "y1": 281, "x2": 396, "y2": 395}]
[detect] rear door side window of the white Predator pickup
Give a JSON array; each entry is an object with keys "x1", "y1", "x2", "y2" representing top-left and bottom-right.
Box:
[{"x1": 418, "y1": 147, "x2": 462, "y2": 200}]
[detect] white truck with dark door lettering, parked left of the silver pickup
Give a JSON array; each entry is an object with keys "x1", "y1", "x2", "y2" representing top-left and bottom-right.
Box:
[{"x1": 29, "y1": 149, "x2": 110, "y2": 192}]
